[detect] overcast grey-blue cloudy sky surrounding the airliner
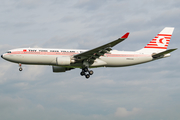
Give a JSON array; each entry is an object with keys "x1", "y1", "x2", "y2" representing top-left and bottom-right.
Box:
[{"x1": 0, "y1": 0, "x2": 180, "y2": 120}]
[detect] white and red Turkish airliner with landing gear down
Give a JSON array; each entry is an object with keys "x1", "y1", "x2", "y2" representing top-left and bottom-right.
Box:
[{"x1": 1, "y1": 27, "x2": 177, "y2": 79}]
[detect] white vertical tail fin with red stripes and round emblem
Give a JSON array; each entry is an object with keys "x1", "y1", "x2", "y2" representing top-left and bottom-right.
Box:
[{"x1": 139, "y1": 27, "x2": 174, "y2": 53}]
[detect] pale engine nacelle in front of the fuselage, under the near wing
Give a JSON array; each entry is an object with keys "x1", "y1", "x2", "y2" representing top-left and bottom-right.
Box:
[{"x1": 56, "y1": 56, "x2": 74, "y2": 66}]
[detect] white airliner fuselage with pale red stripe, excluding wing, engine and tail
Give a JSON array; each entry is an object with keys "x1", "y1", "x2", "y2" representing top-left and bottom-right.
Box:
[{"x1": 3, "y1": 48, "x2": 153, "y2": 68}]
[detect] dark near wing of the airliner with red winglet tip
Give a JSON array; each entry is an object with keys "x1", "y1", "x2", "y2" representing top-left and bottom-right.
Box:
[{"x1": 74, "y1": 33, "x2": 129, "y2": 62}]
